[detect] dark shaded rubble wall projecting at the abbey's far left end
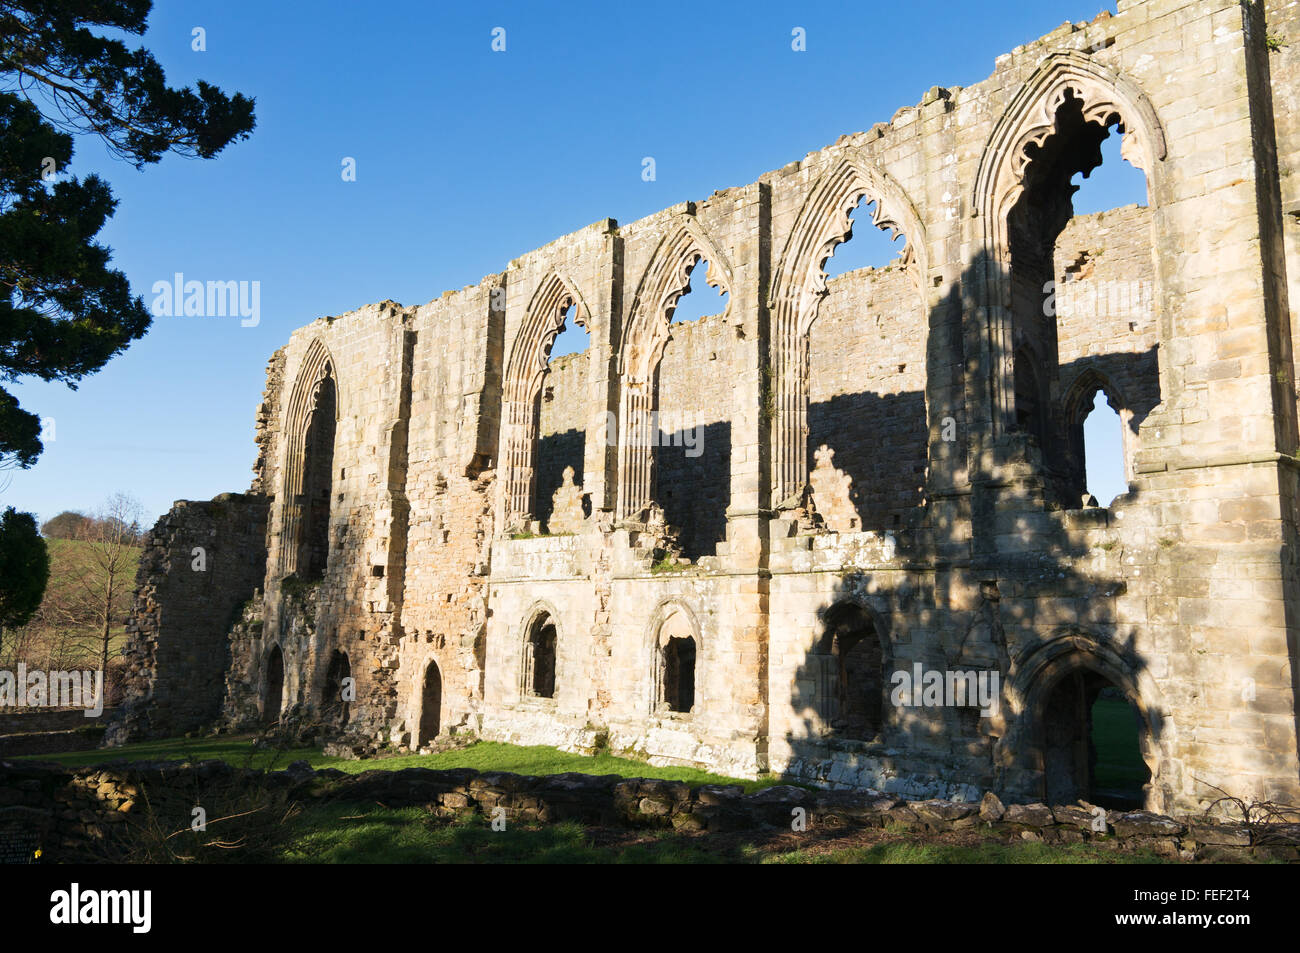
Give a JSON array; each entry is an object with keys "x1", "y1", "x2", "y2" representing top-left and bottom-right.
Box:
[{"x1": 105, "y1": 493, "x2": 267, "y2": 745}]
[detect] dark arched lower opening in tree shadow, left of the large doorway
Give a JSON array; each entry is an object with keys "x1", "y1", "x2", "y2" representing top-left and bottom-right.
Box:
[{"x1": 816, "y1": 602, "x2": 884, "y2": 741}]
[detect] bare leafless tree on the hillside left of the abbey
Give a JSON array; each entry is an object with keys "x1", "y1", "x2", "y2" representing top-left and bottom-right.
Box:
[{"x1": 79, "y1": 493, "x2": 143, "y2": 673}]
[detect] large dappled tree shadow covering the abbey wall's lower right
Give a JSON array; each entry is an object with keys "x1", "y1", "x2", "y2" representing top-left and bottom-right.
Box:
[{"x1": 777, "y1": 254, "x2": 1171, "y2": 809}]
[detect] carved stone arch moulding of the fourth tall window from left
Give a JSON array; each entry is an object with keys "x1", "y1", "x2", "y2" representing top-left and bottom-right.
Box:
[{"x1": 770, "y1": 153, "x2": 930, "y2": 506}]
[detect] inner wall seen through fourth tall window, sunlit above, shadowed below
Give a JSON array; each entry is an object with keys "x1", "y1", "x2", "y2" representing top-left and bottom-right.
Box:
[{"x1": 809, "y1": 265, "x2": 928, "y2": 530}]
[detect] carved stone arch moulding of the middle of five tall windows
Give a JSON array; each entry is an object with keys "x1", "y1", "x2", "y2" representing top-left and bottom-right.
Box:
[{"x1": 618, "y1": 213, "x2": 735, "y2": 519}]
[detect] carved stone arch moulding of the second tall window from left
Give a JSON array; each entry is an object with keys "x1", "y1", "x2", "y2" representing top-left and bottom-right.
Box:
[{"x1": 503, "y1": 272, "x2": 592, "y2": 527}]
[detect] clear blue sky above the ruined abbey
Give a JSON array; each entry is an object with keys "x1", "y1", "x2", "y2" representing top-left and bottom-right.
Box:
[{"x1": 0, "y1": 0, "x2": 1140, "y2": 523}]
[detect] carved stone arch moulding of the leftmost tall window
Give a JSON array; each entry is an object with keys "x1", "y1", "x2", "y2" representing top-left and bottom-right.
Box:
[{"x1": 277, "y1": 338, "x2": 343, "y2": 576}]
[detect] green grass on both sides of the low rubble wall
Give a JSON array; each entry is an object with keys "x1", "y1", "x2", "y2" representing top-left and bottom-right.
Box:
[{"x1": 25, "y1": 736, "x2": 1190, "y2": 865}]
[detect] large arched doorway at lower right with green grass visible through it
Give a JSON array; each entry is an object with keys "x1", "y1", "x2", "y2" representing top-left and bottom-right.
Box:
[{"x1": 1037, "y1": 664, "x2": 1151, "y2": 809}]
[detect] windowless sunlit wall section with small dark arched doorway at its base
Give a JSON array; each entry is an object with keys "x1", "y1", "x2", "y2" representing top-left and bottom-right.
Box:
[{"x1": 390, "y1": 274, "x2": 504, "y2": 748}]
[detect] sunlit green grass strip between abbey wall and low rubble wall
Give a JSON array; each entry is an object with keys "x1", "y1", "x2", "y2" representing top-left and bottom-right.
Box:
[{"x1": 20, "y1": 736, "x2": 780, "y2": 792}]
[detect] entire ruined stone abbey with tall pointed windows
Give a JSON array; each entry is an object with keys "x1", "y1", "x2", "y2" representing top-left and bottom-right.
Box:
[{"x1": 113, "y1": 0, "x2": 1300, "y2": 811}]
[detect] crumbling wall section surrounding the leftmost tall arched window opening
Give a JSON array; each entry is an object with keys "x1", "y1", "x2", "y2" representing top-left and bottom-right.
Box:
[{"x1": 247, "y1": 302, "x2": 412, "y2": 740}]
